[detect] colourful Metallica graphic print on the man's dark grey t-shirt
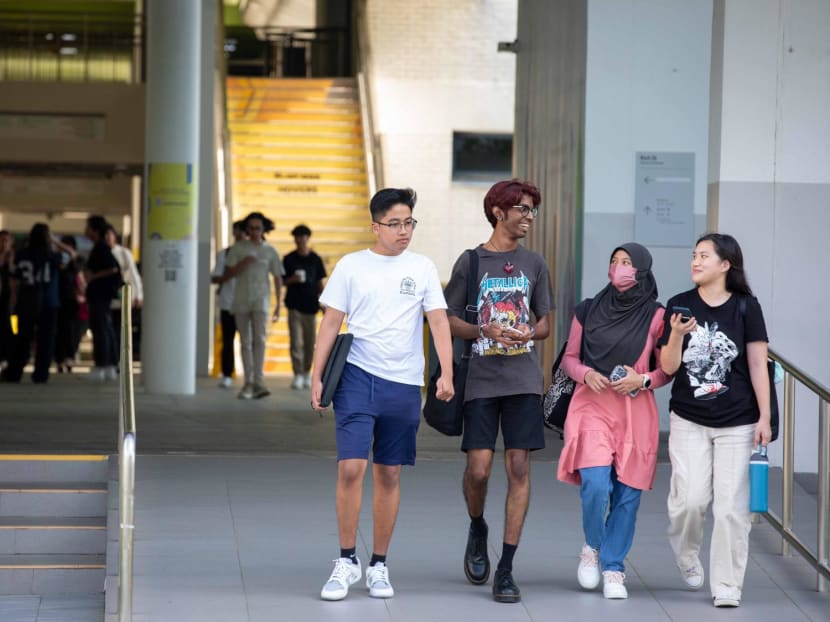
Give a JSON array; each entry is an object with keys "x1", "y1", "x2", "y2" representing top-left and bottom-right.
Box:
[{"x1": 472, "y1": 272, "x2": 533, "y2": 356}]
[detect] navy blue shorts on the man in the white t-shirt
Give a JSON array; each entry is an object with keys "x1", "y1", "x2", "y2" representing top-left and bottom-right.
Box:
[{"x1": 332, "y1": 363, "x2": 421, "y2": 466}]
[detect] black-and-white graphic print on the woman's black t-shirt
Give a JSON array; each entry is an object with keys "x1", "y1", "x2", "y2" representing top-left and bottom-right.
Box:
[{"x1": 683, "y1": 322, "x2": 738, "y2": 400}]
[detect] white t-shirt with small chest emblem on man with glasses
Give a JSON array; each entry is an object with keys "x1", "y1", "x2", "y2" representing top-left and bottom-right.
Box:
[{"x1": 320, "y1": 250, "x2": 447, "y2": 386}]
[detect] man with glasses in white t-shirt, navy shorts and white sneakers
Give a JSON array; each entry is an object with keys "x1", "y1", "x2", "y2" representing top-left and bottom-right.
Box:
[{"x1": 311, "y1": 188, "x2": 453, "y2": 600}]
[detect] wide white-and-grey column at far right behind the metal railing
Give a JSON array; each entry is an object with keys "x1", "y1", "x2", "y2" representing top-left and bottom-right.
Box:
[{"x1": 707, "y1": 0, "x2": 830, "y2": 472}]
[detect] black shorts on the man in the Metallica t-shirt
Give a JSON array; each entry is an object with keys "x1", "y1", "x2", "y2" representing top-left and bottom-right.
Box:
[{"x1": 461, "y1": 393, "x2": 545, "y2": 451}]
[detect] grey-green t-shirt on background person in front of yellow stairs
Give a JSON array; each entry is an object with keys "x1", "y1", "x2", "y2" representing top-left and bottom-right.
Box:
[{"x1": 225, "y1": 240, "x2": 283, "y2": 313}]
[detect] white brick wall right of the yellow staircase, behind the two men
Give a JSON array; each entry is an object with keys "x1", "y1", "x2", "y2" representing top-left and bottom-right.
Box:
[{"x1": 367, "y1": 0, "x2": 518, "y2": 279}]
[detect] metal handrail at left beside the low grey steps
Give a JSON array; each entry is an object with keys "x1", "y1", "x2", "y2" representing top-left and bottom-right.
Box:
[{"x1": 118, "y1": 284, "x2": 135, "y2": 622}]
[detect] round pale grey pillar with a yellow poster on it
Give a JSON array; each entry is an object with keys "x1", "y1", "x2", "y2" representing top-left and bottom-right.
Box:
[{"x1": 141, "y1": 0, "x2": 202, "y2": 394}]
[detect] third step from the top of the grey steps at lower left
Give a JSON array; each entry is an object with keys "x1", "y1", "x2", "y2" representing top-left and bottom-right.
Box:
[{"x1": 0, "y1": 516, "x2": 107, "y2": 555}]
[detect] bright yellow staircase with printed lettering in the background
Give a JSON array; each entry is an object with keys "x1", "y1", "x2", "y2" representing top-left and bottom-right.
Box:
[{"x1": 227, "y1": 77, "x2": 374, "y2": 374}]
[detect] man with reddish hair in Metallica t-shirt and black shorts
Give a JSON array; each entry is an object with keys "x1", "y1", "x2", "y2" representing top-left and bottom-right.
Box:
[{"x1": 442, "y1": 179, "x2": 553, "y2": 603}]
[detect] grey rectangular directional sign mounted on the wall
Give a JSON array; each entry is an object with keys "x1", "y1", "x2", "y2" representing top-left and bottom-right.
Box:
[{"x1": 634, "y1": 151, "x2": 695, "y2": 246}]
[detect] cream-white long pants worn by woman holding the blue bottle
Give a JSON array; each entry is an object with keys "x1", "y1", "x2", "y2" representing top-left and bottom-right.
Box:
[{"x1": 668, "y1": 413, "x2": 755, "y2": 599}]
